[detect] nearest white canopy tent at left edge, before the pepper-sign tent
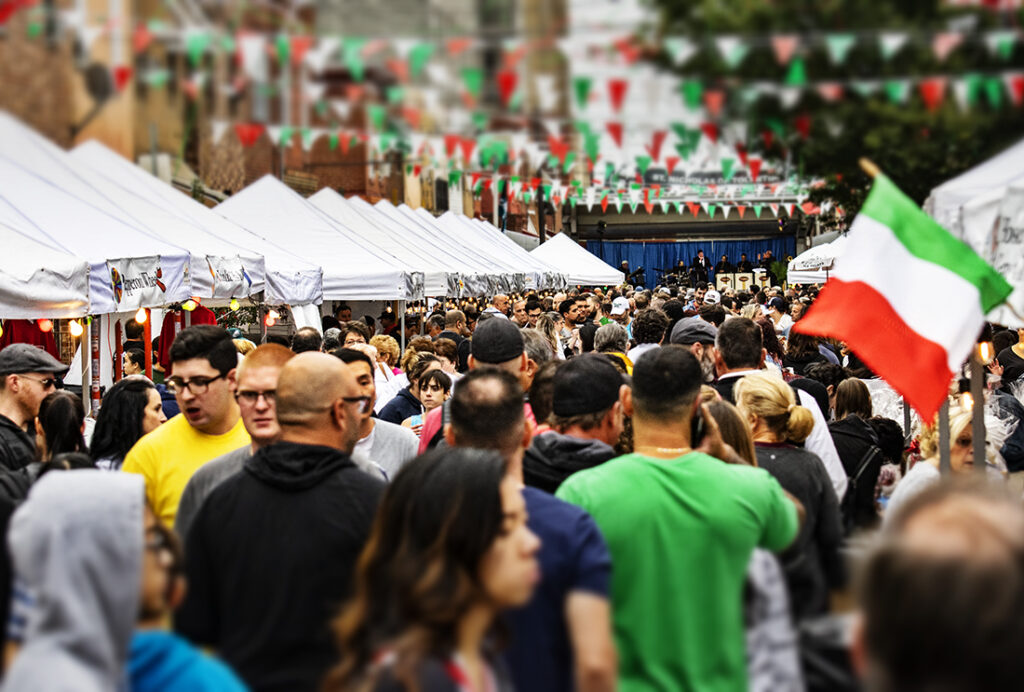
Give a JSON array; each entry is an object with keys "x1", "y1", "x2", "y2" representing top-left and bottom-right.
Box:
[{"x1": 0, "y1": 223, "x2": 89, "y2": 319}]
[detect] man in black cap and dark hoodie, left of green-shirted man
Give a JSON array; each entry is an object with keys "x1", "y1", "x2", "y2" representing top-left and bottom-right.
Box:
[{"x1": 522, "y1": 353, "x2": 629, "y2": 494}]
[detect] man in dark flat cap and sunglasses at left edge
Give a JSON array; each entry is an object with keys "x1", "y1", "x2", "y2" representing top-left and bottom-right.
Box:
[{"x1": 0, "y1": 344, "x2": 68, "y2": 471}]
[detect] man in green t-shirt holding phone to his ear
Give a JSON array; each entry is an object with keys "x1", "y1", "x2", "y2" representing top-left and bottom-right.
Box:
[{"x1": 557, "y1": 345, "x2": 799, "y2": 692}]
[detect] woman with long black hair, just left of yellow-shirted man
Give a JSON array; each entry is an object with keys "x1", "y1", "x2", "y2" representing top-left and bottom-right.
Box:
[{"x1": 91, "y1": 377, "x2": 167, "y2": 471}]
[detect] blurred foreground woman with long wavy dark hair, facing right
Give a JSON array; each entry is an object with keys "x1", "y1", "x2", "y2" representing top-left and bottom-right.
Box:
[{"x1": 325, "y1": 448, "x2": 540, "y2": 692}]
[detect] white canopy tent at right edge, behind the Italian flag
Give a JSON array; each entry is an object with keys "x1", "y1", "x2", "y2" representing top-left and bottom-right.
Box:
[{"x1": 925, "y1": 135, "x2": 1024, "y2": 237}]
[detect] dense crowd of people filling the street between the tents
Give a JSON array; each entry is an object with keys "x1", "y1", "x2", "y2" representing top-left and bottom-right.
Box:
[{"x1": 0, "y1": 280, "x2": 1024, "y2": 692}]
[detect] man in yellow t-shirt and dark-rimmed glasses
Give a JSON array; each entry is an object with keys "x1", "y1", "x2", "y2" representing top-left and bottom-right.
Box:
[{"x1": 121, "y1": 325, "x2": 252, "y2": 526}]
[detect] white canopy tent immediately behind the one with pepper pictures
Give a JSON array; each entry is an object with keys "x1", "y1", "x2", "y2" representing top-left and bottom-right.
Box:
[{"x1": 71, "y1": 141, "x2": 324, "y2": 305}]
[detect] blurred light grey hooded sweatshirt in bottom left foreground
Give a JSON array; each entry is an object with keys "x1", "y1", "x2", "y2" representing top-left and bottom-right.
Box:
[{"x1": 3, "y1": 471, "x2": 145, "y2": 692}]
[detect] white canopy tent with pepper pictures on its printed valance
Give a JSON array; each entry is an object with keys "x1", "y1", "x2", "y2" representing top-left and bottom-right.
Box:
[{"x1": 0, "y1": 157, "x2": 191, "y2": 314}]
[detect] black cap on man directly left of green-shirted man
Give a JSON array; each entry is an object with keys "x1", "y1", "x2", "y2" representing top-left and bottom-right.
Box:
[{"x1": 551, "y1": 353, "x2": 623, "y2": 418}]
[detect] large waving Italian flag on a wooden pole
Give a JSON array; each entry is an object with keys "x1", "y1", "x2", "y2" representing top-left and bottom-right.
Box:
[{"x1": 794, "y1": 175, "x2": 1013, "y2": 421}]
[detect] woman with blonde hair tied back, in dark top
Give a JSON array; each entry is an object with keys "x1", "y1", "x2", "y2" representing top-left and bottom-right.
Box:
[{"x1": 734, "y1": 373, "x2": 844, "y2": 619}]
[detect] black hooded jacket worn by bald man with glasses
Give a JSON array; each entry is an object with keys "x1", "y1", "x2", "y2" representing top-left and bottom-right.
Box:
[{"x1": 175, "y1": 442, "x2": 384, "y2": 692}]
